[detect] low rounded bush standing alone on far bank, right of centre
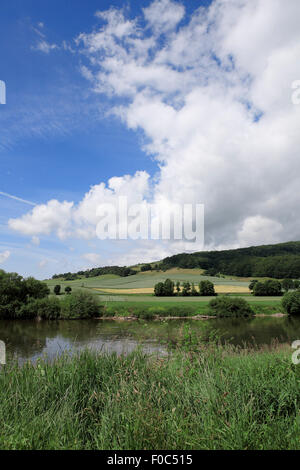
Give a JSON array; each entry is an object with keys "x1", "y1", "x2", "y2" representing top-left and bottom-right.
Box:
[{"x1": 209, "y1": 295, "x2": 254, "y2": 317}]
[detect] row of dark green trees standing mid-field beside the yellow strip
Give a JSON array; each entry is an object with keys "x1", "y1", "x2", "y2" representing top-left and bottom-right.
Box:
[{"x1": 154, "y1": 279, "x2": 216, "y2": 297}]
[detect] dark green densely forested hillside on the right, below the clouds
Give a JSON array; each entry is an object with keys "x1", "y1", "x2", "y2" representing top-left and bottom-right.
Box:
[{"x1": 160, "y1": 242, "x2": 300, "y2": 279}]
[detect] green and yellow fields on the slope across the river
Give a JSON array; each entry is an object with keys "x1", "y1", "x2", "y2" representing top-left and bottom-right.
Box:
[{"x1": 47, "y1": 268, "x2": 281, "y2": 317}]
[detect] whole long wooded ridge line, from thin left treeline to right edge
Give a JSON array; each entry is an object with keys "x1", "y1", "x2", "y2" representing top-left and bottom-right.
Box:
[{"x1": 52, "y1": 241, "x2": 300, "y2": 281}]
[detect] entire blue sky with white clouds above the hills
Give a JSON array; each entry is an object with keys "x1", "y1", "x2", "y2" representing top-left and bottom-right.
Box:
[{"x1": 0, "y1": 0, "x2": 300, "y2": 278}]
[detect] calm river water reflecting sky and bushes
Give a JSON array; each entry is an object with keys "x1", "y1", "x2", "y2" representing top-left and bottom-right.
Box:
[{"x1": 0, "y1": 317, "x2": 300, "y2": 361}]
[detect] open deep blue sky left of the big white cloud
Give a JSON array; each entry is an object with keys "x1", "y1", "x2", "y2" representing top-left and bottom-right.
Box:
[{"x1": 0, "y1": 0, "x2": 213, "y2": 277}]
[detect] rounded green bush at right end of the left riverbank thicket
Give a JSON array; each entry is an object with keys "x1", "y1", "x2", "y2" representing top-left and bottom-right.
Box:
[{"x1": 61, "y1": 291, "x2": 100, "y2": 318}]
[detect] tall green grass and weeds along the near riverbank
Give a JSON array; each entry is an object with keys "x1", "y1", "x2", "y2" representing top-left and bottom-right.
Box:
[{"x1": 0, "y1": 344, "x2": 300, "y2": 450}]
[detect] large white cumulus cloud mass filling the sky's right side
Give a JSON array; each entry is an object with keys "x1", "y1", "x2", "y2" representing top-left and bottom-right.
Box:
[{"x1": 10, "y1": 0, "x2": 300, "y2": 264}]
